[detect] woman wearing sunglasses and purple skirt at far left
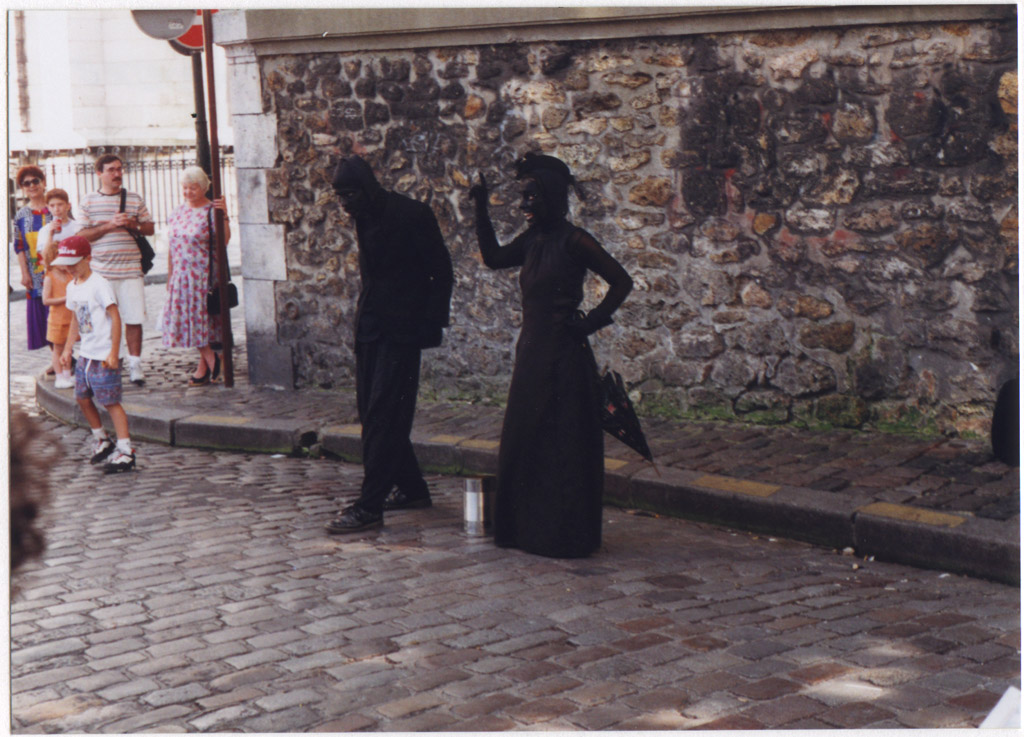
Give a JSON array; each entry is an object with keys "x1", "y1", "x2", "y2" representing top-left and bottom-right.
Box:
[{"x1": 14, "y1": 166, "x2": 53, "y2": 350}]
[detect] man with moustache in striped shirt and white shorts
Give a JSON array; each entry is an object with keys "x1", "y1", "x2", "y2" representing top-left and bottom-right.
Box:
[{"x1": 78, "y1": 154, "x2": 155, "y2": 385}]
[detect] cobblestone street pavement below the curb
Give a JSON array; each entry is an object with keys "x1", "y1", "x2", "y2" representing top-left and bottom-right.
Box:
[{"x1": 10, "y1": 286, "x2": 1021, "y2": 733}]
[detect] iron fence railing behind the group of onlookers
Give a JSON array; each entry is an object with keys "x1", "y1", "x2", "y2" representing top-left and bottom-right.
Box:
[{"x1": 7, "y1": 145, "x2": 238, "y2": 229}]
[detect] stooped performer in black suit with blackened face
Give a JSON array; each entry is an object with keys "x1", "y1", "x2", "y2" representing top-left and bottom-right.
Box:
[{"x1": 327, "y1": 156, "x2": 455, "y2": 534}]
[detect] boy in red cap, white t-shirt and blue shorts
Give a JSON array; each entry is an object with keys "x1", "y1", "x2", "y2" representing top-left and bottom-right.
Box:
[{"x1": 53, "y1": 235, "x2": 135, "y2": 473}]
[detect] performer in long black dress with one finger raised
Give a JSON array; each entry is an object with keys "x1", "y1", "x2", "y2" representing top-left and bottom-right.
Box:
[{"x1": 469, "y1": 155, "x2": 633, "y2": 558}]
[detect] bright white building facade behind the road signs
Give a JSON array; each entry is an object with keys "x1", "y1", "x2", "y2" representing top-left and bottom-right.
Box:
[{"x1": 7, "y1": 8, "x2": 232, "y2": 151}]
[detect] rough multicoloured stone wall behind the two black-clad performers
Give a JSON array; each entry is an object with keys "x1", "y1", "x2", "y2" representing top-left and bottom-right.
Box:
[{"x1": 258, "y1": 19, "x2": 1018, "y2": 433}]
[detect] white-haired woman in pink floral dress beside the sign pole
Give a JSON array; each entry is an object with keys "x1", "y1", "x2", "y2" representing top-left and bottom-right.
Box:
[{"x1": 161, "y1": 167, "x2": 231, "y2": 386}]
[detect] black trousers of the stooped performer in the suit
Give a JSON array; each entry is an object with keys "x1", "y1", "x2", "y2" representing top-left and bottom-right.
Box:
[{"x1": 355, "y1": 340, "x2": 430, "y2": 514}]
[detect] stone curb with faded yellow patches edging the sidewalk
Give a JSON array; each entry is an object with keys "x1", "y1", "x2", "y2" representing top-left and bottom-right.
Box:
[{"x1": 36, "y1": 380, "x2": 1020, "y2": 586}]
